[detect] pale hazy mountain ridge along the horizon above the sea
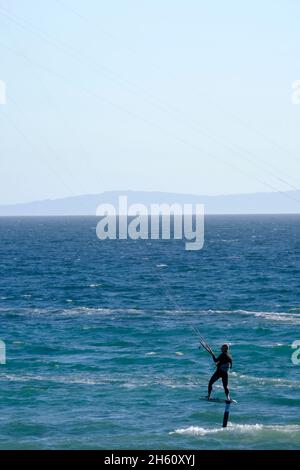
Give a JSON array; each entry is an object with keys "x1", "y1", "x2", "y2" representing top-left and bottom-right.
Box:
[{"x1": 0, "y1": 191, "x2": 300, "y2": 216}]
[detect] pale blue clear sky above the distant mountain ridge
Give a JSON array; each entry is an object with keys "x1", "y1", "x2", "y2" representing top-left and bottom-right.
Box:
[{"x1": 0, "y1": 0, "x2": 300, "y2": 204}]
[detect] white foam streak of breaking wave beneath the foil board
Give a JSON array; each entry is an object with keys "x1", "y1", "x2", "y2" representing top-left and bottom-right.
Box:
[{"x1": 169, "y1": 423, "x2": 300, "y2": 436}]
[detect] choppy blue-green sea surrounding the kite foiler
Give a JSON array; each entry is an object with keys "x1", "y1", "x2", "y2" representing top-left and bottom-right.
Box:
[{"x1": 0, "y1": 215, "x2": 300, "y2": 449}]
